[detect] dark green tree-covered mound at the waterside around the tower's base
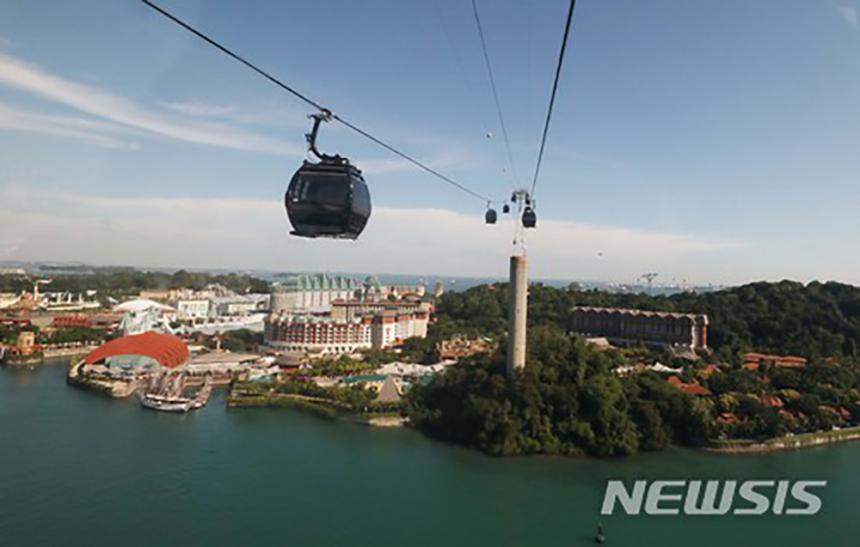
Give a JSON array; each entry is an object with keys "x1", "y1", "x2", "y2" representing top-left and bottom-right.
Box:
[{"x1": 407, "y1": 326, "x2": 712, "y2": 456}]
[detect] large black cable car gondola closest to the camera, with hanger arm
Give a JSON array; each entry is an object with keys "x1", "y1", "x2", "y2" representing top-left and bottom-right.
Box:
[{"x1": 284, "y1": 111, "x2": 372, "y2": 239}]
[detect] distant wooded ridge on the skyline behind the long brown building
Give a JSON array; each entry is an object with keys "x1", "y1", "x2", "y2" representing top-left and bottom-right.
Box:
[{"x1": 437, "y1": 281, "x2": 860, "y2": 361}]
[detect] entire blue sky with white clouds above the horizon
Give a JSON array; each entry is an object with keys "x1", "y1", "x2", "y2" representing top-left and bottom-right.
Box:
[{"x1": 0, "y1": 0, "x2": 860, "y2": 283}]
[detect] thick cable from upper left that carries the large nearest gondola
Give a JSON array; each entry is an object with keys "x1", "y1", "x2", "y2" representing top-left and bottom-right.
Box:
[{"x1": 141, "y1": 0, "x2": 492, "y2": 202}]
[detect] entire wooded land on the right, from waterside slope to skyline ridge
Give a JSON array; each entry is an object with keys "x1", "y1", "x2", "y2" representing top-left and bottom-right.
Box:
[{"x1": 407, "y1": 281, "x2": 860, "y2": 457}]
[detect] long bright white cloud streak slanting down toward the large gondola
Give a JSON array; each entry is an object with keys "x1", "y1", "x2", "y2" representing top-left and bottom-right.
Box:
[{"x1": 0, "y1": 53, "x2": 304, "y2": 157}]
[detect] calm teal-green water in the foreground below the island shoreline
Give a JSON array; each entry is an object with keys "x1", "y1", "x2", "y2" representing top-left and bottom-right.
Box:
[{"x1": 0, "y1": 362, "x2": 860, "y2": 547}]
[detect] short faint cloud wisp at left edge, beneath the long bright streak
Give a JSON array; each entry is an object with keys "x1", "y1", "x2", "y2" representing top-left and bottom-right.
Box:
[{"x1": 0, "y1": 103, "x2": 138, "y2": 150}]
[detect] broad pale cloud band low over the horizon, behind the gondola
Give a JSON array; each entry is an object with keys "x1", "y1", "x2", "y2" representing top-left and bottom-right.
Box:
[{"x1": 0, "y1": 188, "x2": 743, "y2": 278}]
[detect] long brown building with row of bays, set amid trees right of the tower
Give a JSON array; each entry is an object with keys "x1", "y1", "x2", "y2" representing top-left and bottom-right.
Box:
[{"x1": 570, "y1": 306, "x2": 708, "y2": 351}]
